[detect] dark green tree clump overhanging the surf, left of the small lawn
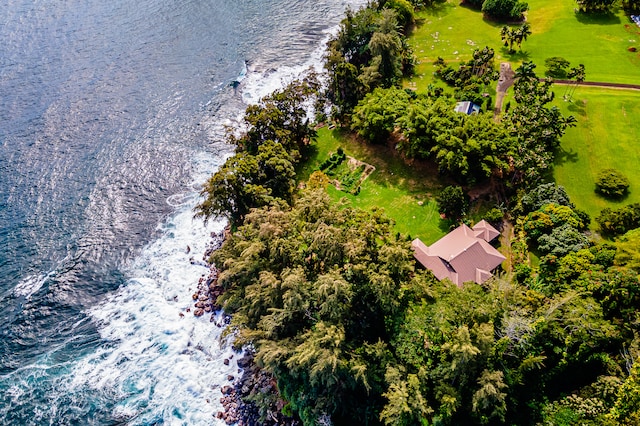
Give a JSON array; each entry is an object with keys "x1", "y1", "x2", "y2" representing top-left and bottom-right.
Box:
[{"x1": 196, "y1": 76, "x2": 318, "y2": 225}]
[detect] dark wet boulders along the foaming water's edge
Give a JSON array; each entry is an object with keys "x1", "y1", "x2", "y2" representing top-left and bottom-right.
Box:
[{"x1": 186, "y1": 229, "x2": 301, "y2": 426}]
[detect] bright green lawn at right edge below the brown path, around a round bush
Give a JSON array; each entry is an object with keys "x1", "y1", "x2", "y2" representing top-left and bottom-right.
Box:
[{"x1": 554, "y1": 86, "x2": 640, "y2": 221}]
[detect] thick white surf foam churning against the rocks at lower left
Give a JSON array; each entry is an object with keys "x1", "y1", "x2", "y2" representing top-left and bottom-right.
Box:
[{"x1": 71, "y1": 151, "x2": 237, "y2": 425}]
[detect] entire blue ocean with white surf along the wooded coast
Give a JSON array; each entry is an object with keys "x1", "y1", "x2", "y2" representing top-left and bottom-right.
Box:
[{"x1": 0, "y1": 0, "x2": 364, "y2": 425}]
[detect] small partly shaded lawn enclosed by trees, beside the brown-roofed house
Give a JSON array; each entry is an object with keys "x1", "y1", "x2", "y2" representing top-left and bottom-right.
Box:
[{"x1": 298, "y1": 127, "x2": 448, "y2": 244}]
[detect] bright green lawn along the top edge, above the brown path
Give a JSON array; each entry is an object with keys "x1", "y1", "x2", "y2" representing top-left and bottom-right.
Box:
[{"x1": 410, "y1": 0, "x2": 640, "y2": 91}]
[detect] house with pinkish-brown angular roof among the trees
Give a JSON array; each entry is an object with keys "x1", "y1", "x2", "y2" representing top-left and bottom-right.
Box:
[{"x1": 411, "y1": 220, "x2": 505, "y2": 287}]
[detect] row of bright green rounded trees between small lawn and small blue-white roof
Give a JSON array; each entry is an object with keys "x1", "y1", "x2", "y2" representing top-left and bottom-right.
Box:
[{"x1": 352, "y1": 88, "x2": 514, "y2": 183}]
